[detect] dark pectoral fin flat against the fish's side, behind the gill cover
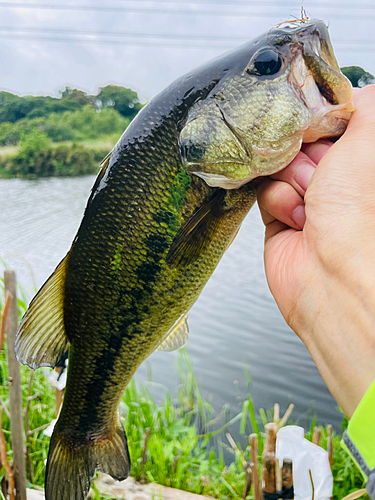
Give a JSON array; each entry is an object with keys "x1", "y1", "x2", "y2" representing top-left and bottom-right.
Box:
[{"x1": 166, "y1": 189, "x2": 226, "y2": 267}]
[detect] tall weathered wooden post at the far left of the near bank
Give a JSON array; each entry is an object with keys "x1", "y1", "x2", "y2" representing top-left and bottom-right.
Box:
[{"x1": 4, "y1": 271, "x2": 26, "y2": 500}]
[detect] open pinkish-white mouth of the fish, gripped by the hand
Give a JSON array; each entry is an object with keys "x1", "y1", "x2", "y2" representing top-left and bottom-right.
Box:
[{"x1": 288, "y1": 21, "x2": 355, "y2": 142}]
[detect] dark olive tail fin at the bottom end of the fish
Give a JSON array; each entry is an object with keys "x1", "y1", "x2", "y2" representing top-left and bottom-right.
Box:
[{"x1": 45, "y1": 422, "x2": 130, "y2": 500}]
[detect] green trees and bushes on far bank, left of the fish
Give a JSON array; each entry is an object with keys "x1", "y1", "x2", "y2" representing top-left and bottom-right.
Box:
[{"x1": 0, "y1": 85, "x2": 142, "y2": 178}]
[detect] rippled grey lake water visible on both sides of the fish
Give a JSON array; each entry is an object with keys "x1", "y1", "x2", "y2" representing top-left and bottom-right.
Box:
[{"x1": 0, "y1": 176, "x2": 342, "y2": 436}]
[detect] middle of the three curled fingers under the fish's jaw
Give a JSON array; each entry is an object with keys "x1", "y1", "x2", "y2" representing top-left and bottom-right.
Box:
[{"x1": 270, "y1": 152, "x2": 316, "y2": 196}]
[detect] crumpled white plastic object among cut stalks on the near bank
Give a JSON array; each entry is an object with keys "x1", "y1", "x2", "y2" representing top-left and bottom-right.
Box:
[{"x1": 276, "y1": 425, "x2": 333, "y2": 500}]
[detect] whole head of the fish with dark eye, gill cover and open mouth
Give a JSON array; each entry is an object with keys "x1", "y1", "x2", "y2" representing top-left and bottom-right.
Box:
[{"x1": 179, "y1": 20, "x2": 354, "y2": 189}]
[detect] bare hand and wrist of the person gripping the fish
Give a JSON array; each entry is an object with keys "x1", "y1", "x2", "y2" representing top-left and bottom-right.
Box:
[{"x1": 258, "y1": 85, "x2": 375, "y2": 418}]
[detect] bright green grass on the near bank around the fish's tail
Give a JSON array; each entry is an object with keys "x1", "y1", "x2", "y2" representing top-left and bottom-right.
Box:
[{"x1": 0, "y1": 280, "x2": 370, "y2": 500}]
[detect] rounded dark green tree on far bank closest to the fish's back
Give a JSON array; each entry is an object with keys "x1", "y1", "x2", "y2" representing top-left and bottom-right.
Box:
[{"x1": 97, "y1": 85, "x2": 142, "y2": 120}]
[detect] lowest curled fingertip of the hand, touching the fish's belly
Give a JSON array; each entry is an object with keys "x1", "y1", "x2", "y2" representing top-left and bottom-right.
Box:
[{"x1": 257, "y1": 179, "x2": 306, "y2": 229}]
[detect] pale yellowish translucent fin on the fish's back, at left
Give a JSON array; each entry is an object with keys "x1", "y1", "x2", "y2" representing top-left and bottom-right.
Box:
[{"x1": 15, "y1": 254, "x2": 69, "y2": 369}]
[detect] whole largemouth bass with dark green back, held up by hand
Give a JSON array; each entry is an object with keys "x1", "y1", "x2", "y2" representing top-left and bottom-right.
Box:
[{"x1": 16, "y1": 21, "x2": 353, "y2": 500}]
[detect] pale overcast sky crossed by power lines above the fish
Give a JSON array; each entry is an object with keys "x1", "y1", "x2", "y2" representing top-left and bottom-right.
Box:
[{"x1": 0, "y1": 0, "x2": 375, "y2": 100}]
